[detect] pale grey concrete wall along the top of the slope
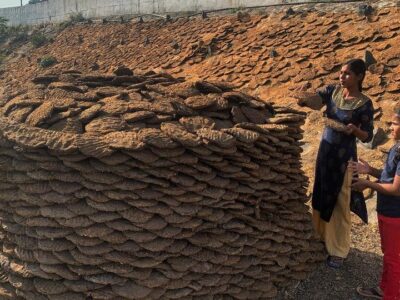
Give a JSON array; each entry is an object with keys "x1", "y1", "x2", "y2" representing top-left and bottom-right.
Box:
[{"x1": 0, "y1": 0, "x2": 340, "y2": 25}]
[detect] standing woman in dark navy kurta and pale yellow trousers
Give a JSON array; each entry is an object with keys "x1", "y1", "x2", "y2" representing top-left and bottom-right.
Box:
[{"x1": 299, "y1": 59, "x2": 373, "y2": 268}]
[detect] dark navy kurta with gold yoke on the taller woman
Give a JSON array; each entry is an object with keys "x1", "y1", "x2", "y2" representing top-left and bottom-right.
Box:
[{"x1": 312, "y1": 86, "x2": 373, "y2": 222}]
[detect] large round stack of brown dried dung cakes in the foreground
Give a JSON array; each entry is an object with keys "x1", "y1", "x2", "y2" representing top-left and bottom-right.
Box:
[{"x1": 0, "y1": 67, "x2": 323, "y2": 300}]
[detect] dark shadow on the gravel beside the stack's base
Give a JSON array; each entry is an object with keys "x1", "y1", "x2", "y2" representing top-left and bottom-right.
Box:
[{"x1": 277, "y1": 249, "x2": 382, "y2": 300}]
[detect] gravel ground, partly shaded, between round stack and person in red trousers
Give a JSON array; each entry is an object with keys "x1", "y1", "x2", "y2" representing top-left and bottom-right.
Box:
[{"x1": 278, "y1": 199, "x2": 382, "y2": 300}]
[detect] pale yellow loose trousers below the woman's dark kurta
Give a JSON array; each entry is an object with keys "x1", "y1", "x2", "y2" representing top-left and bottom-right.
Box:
[{"x1": 313, "y1": 169, "x2": 353, "y2": 258}]
